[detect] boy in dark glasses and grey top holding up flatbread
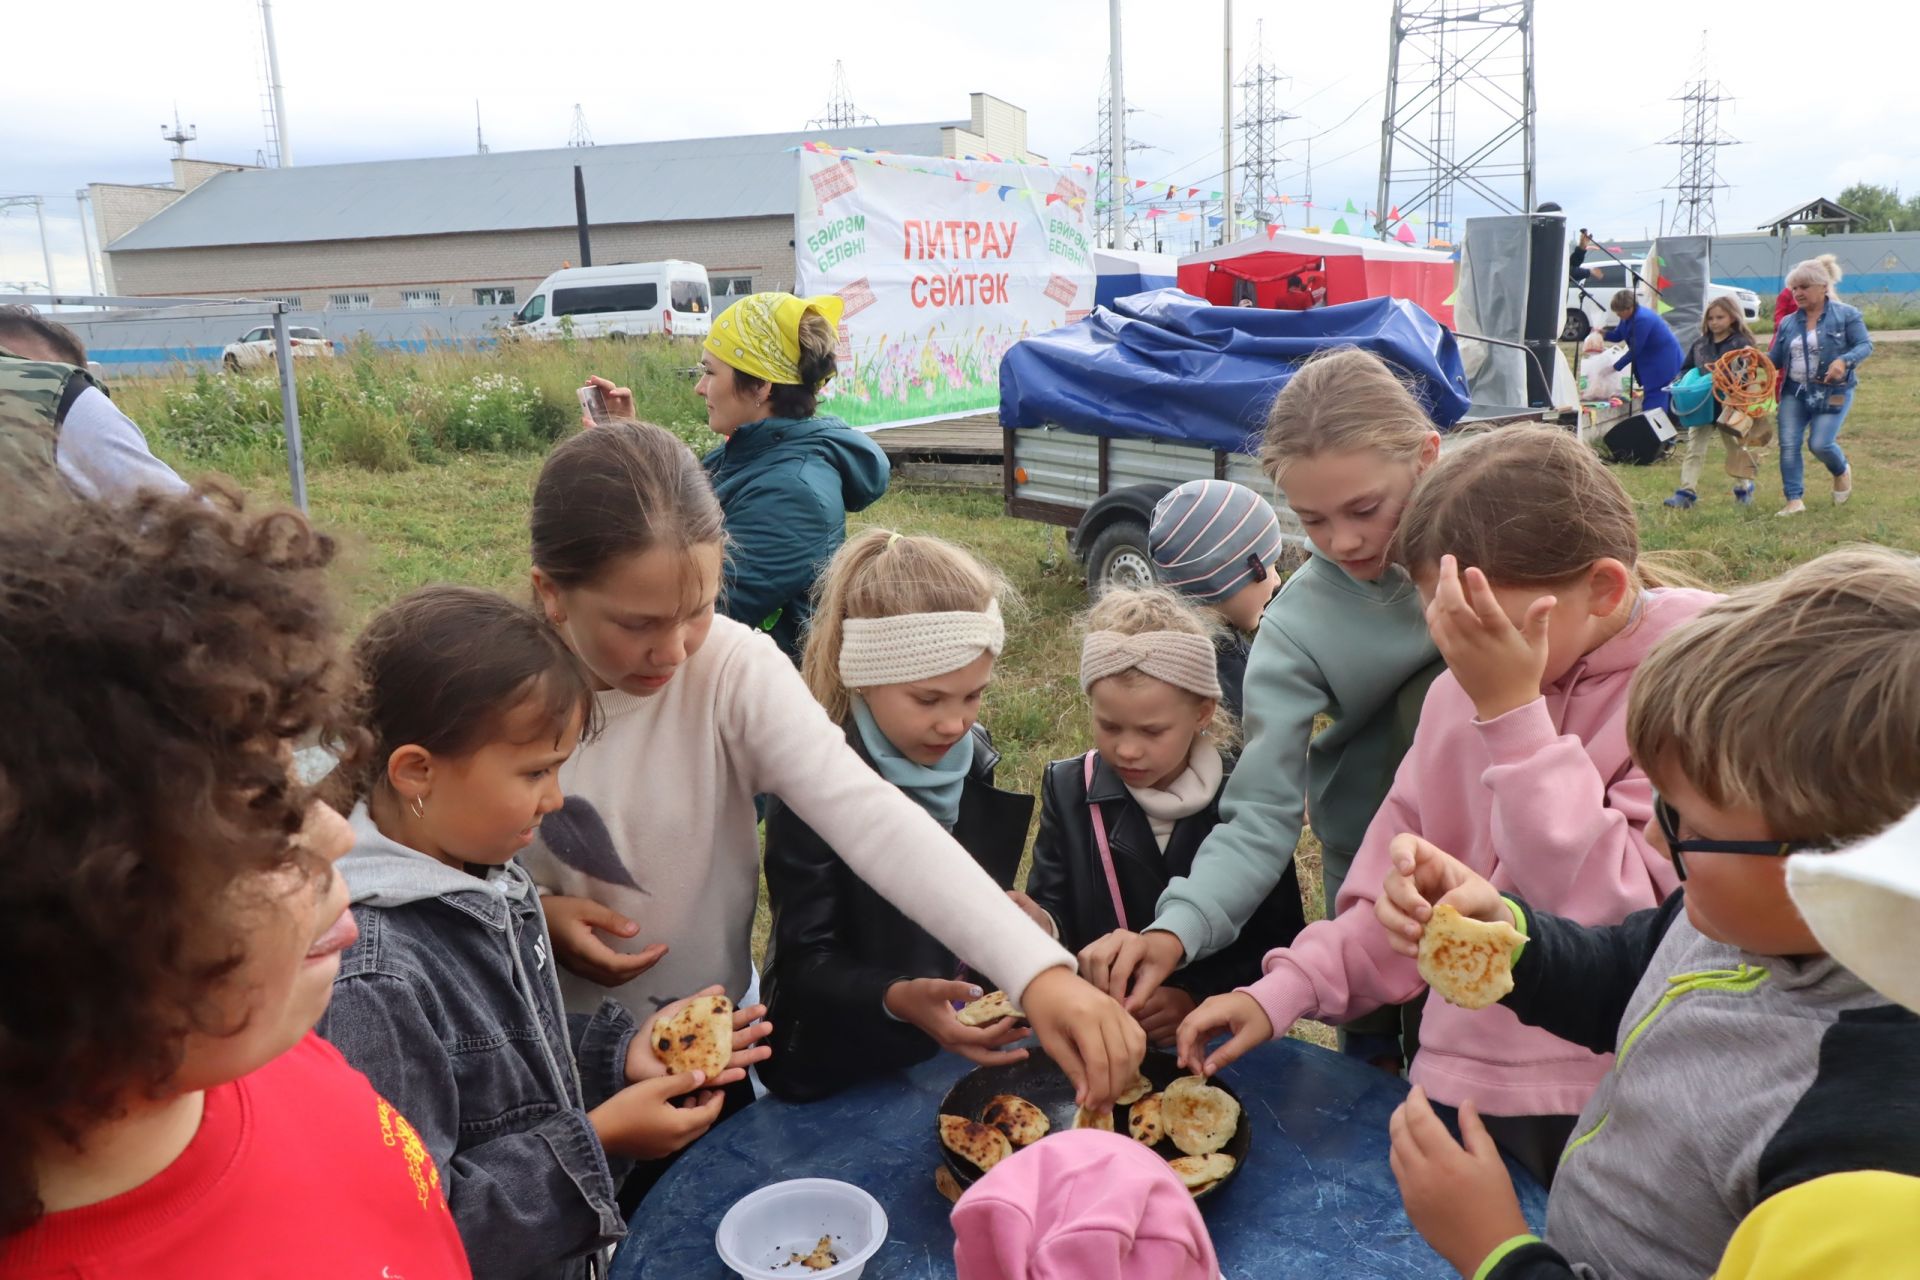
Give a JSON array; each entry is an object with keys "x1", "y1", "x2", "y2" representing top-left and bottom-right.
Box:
[{"x1": 1379, "y1": 549, "x2": 1920, "y2": 1280}]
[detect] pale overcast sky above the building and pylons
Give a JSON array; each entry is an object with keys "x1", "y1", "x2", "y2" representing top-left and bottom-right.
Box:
[{"x1": 0, "y1": 0, "x2": 1920, "y2": 292}]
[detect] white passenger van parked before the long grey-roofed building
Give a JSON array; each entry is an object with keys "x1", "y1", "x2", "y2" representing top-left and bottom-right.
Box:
[{"x1": 513, "y1": 257, "x2": 712, "y2": 338}]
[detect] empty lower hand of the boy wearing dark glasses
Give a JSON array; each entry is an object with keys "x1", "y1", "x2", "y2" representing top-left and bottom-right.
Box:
[{"x1": 1388, "y1": 1084, "x2": 1532, "y2": 1276}]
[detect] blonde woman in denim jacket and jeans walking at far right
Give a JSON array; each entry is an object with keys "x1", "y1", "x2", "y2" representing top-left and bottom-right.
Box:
[{"x1": 1766, "y1": 253, "x2": 1874, "y2": 516}]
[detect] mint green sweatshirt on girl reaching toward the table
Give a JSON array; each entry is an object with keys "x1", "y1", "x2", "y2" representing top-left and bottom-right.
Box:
[{"x1": 1150, "y1": 549, "x2": 1440, "y2": 961}]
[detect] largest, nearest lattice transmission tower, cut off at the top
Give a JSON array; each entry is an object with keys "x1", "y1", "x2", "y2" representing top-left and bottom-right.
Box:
[{"x1": 1373, "y1": 0, "x2": 1534, "y2": 240}]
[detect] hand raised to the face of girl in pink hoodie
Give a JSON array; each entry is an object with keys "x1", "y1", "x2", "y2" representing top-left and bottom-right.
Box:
[{"x1": 1427, "y1": 555, "x2": 1555, "y2": 720}]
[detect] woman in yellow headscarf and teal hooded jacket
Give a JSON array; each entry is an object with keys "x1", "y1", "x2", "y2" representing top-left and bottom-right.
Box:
[{"x1": 695, "y1": 294, "x2": 887, "y2": 662}]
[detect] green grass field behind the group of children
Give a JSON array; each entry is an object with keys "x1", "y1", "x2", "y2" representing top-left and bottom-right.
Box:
[{"x1": 145, "y1": 344, "x2": 1920, "y2": 1020}]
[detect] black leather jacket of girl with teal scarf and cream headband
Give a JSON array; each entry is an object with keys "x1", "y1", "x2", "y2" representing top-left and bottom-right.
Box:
[{"x1": 760, "y1": 725, "x2": 1033, "y2": 1102}]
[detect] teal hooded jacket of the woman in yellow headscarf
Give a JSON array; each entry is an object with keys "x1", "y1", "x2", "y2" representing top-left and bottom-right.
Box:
[{"x1": 701, "y1": 418, "x2": 889, "y2": 662}]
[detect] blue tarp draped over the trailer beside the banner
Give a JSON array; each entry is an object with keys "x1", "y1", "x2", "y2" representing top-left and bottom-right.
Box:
[{"x1": 1000, "y1": 290, "x2": 1471, "y2": 453}]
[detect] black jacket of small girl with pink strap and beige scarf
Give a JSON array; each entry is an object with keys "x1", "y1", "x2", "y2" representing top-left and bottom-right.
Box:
[{"x1": 1027, "y1": 756, "x2": 1306, "y2": 1000}]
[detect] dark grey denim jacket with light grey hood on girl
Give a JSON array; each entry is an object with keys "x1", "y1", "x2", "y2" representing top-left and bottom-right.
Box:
[{"x1": 319, "y1": 804, "x2": 636, "y2": 1280}]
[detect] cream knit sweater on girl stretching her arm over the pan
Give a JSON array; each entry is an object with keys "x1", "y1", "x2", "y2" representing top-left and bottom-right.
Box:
[{"x1": 522, "y1": 618, "x2": 1073, "y2": 1017}]
